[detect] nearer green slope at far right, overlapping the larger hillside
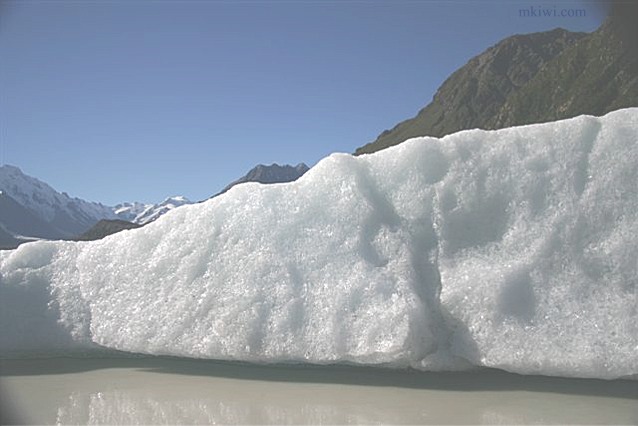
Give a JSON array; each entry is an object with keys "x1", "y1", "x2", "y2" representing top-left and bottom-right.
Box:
[{"x1": 496, "y1": 17, "x2": 638, "y2": 128}]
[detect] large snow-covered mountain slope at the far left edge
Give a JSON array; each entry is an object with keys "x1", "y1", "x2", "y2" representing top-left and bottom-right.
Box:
[{"x1": 0, "y1": 165, "x2": 116, "y2": 238}]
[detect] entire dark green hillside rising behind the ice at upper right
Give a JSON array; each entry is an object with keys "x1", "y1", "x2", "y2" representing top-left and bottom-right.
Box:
[{"x1": 356, "y1": 12, "x2": 638, "y2": 154}]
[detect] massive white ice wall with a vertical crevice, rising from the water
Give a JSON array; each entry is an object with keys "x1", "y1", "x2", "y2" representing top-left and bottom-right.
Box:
[{"x1": 0, "y1": 108, "x2": 638, "y2": 379}]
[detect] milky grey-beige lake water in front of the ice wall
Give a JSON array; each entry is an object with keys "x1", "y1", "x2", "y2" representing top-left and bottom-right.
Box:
[{"x1": 0, "y1": 357, "x2": 638, "y2": 424}]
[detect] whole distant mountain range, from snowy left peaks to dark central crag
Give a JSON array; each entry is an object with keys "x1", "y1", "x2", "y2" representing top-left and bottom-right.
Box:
[{"x1": 0, "y1": 163, "x2": 308, "y2": 245}]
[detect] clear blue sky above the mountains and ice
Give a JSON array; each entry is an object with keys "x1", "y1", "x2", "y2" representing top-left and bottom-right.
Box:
[{"x1": 0, "y1": 0, "x2": 604, "y2": 204}]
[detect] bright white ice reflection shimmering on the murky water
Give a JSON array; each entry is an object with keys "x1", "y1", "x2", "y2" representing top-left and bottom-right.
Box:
[{"x1": 56, "y1": 391, "x2": 411, "y2": 424}]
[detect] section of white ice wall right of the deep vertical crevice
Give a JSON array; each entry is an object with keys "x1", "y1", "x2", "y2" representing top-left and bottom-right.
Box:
[{"x1": 439, "y1": 109, "x2": 638, "y2": 377}]
